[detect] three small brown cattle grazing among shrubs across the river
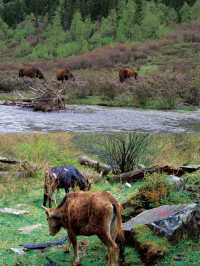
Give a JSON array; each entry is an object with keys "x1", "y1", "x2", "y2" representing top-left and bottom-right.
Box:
[{"x1": 19, "y1": 67, "x2": 138, "y2": 82}]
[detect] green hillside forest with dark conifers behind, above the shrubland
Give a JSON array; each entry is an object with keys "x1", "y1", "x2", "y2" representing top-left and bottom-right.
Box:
[{"x1": 0, "y1": 0, "x2": 200, "y2": 58}]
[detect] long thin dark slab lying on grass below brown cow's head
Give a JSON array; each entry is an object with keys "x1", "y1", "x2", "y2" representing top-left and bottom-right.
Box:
[{"x1": 22, "y1": 237, "x2": 67, "y2": 250}]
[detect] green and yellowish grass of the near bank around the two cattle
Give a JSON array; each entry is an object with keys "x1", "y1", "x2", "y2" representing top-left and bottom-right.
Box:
[{"x1": 0, "y1": 133, "x2": 200, "y2": 266}]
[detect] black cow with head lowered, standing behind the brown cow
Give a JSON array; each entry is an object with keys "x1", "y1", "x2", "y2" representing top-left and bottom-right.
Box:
[{"x1": 43, "y1": 165, "x2": 91, "y2": 207}]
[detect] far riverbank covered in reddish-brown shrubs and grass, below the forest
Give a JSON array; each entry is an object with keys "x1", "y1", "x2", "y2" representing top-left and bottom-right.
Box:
[{"x1": 0, "y1": 22, "x2": 200, "y2": 110}]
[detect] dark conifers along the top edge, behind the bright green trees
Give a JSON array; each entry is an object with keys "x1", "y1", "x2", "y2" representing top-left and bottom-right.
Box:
[{"x1": 0, "y1": 0, "x2": 198, "y2": 27}]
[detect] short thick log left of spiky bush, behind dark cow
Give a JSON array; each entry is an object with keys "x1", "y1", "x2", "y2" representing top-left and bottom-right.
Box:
[{"x1": 79, "y1": 156, "x2": 112, "y2": 176}]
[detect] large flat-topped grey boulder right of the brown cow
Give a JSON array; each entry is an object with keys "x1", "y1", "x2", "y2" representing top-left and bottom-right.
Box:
[{"x1": 123, "y1": 202, "x2": 200, "y2": 241}]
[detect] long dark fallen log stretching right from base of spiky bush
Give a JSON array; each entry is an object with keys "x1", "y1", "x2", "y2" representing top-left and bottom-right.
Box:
[{"x1": 113, "y1": 165, "x2": 185, "y2": 183}]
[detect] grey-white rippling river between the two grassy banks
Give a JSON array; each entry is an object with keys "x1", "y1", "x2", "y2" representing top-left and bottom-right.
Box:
[{"x1": 0, "y1": 105, "x2": 200, "y2": 133}]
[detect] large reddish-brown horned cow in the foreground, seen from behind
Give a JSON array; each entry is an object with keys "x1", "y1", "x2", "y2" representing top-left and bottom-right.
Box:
[{"x1": 43, "y1": 191, "x2": 123, "y2": 266}]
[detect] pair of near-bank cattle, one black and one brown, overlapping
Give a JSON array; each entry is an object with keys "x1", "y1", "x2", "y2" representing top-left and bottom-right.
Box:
[{"x1": 42, "y1": 165, "x2": 124, "y2": 266}]
